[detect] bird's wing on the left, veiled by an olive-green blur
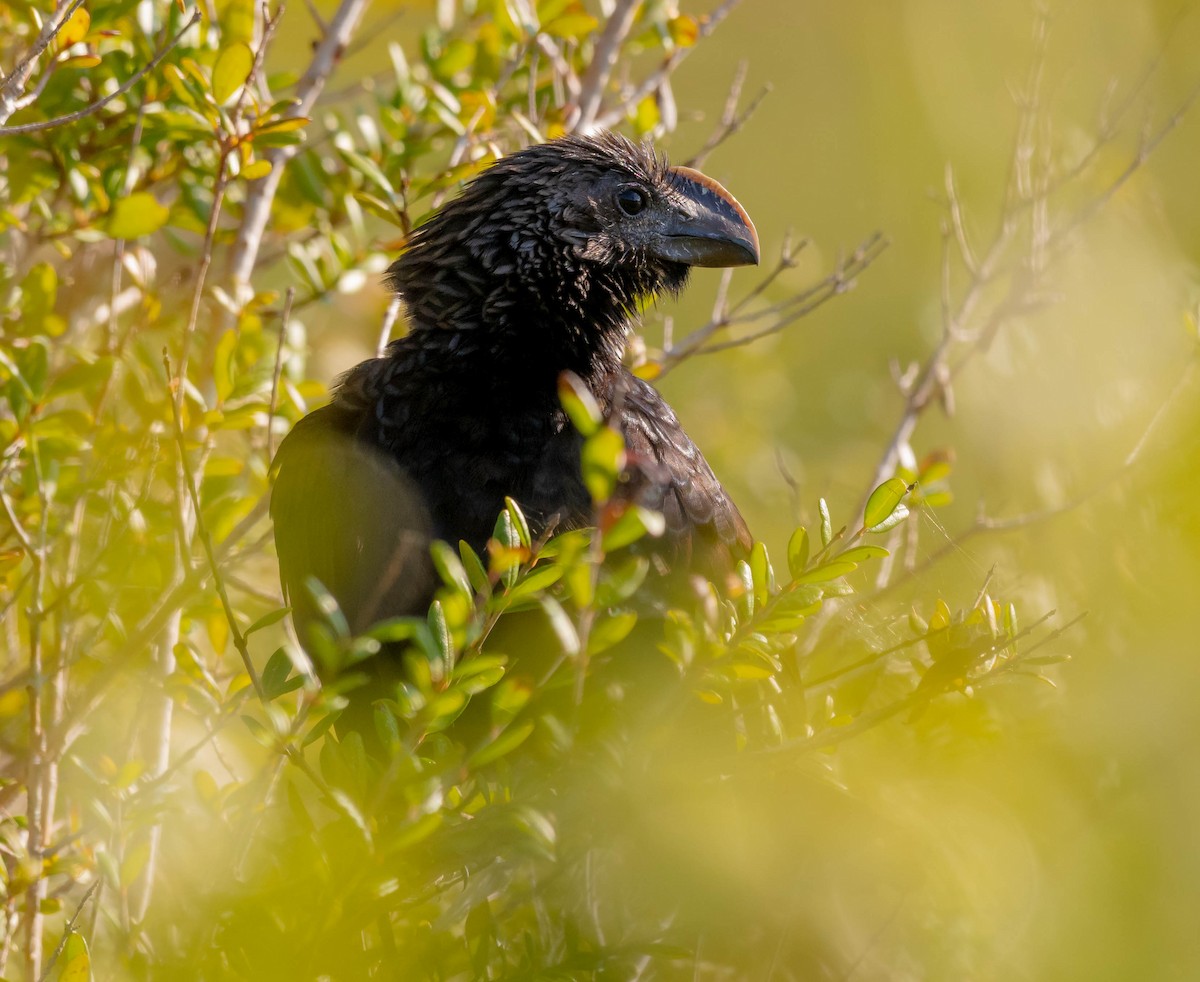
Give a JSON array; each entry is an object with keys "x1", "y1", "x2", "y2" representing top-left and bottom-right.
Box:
[{"x1": 271, "y1": 403, "x2": 434, "y2": 641}]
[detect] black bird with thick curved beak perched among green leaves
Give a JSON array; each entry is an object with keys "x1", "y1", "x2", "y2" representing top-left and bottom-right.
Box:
[{"x1": 271, "y1": 133, "x2": 758, "y2": 637}]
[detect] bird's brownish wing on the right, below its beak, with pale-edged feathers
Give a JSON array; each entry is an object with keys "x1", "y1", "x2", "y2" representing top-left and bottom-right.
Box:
[{"x1": 619, "y1": 376, "x2": 752, "y2": 579}]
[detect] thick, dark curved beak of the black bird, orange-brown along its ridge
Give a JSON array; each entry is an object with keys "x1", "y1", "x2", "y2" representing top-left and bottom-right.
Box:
[{"x1": 654, "y1": 167, "x2": 758, "y2": 267}]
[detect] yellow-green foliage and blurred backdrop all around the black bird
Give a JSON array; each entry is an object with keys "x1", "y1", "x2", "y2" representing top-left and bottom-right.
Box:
[{"x1": 0, "y1": 0, "x2": 1200, "y2": 980}]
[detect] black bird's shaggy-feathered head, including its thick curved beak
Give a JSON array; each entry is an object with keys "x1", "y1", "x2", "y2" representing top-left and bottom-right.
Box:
[{"x1": 389, "y1": 133, "x2": 758, "y2": 370}]
